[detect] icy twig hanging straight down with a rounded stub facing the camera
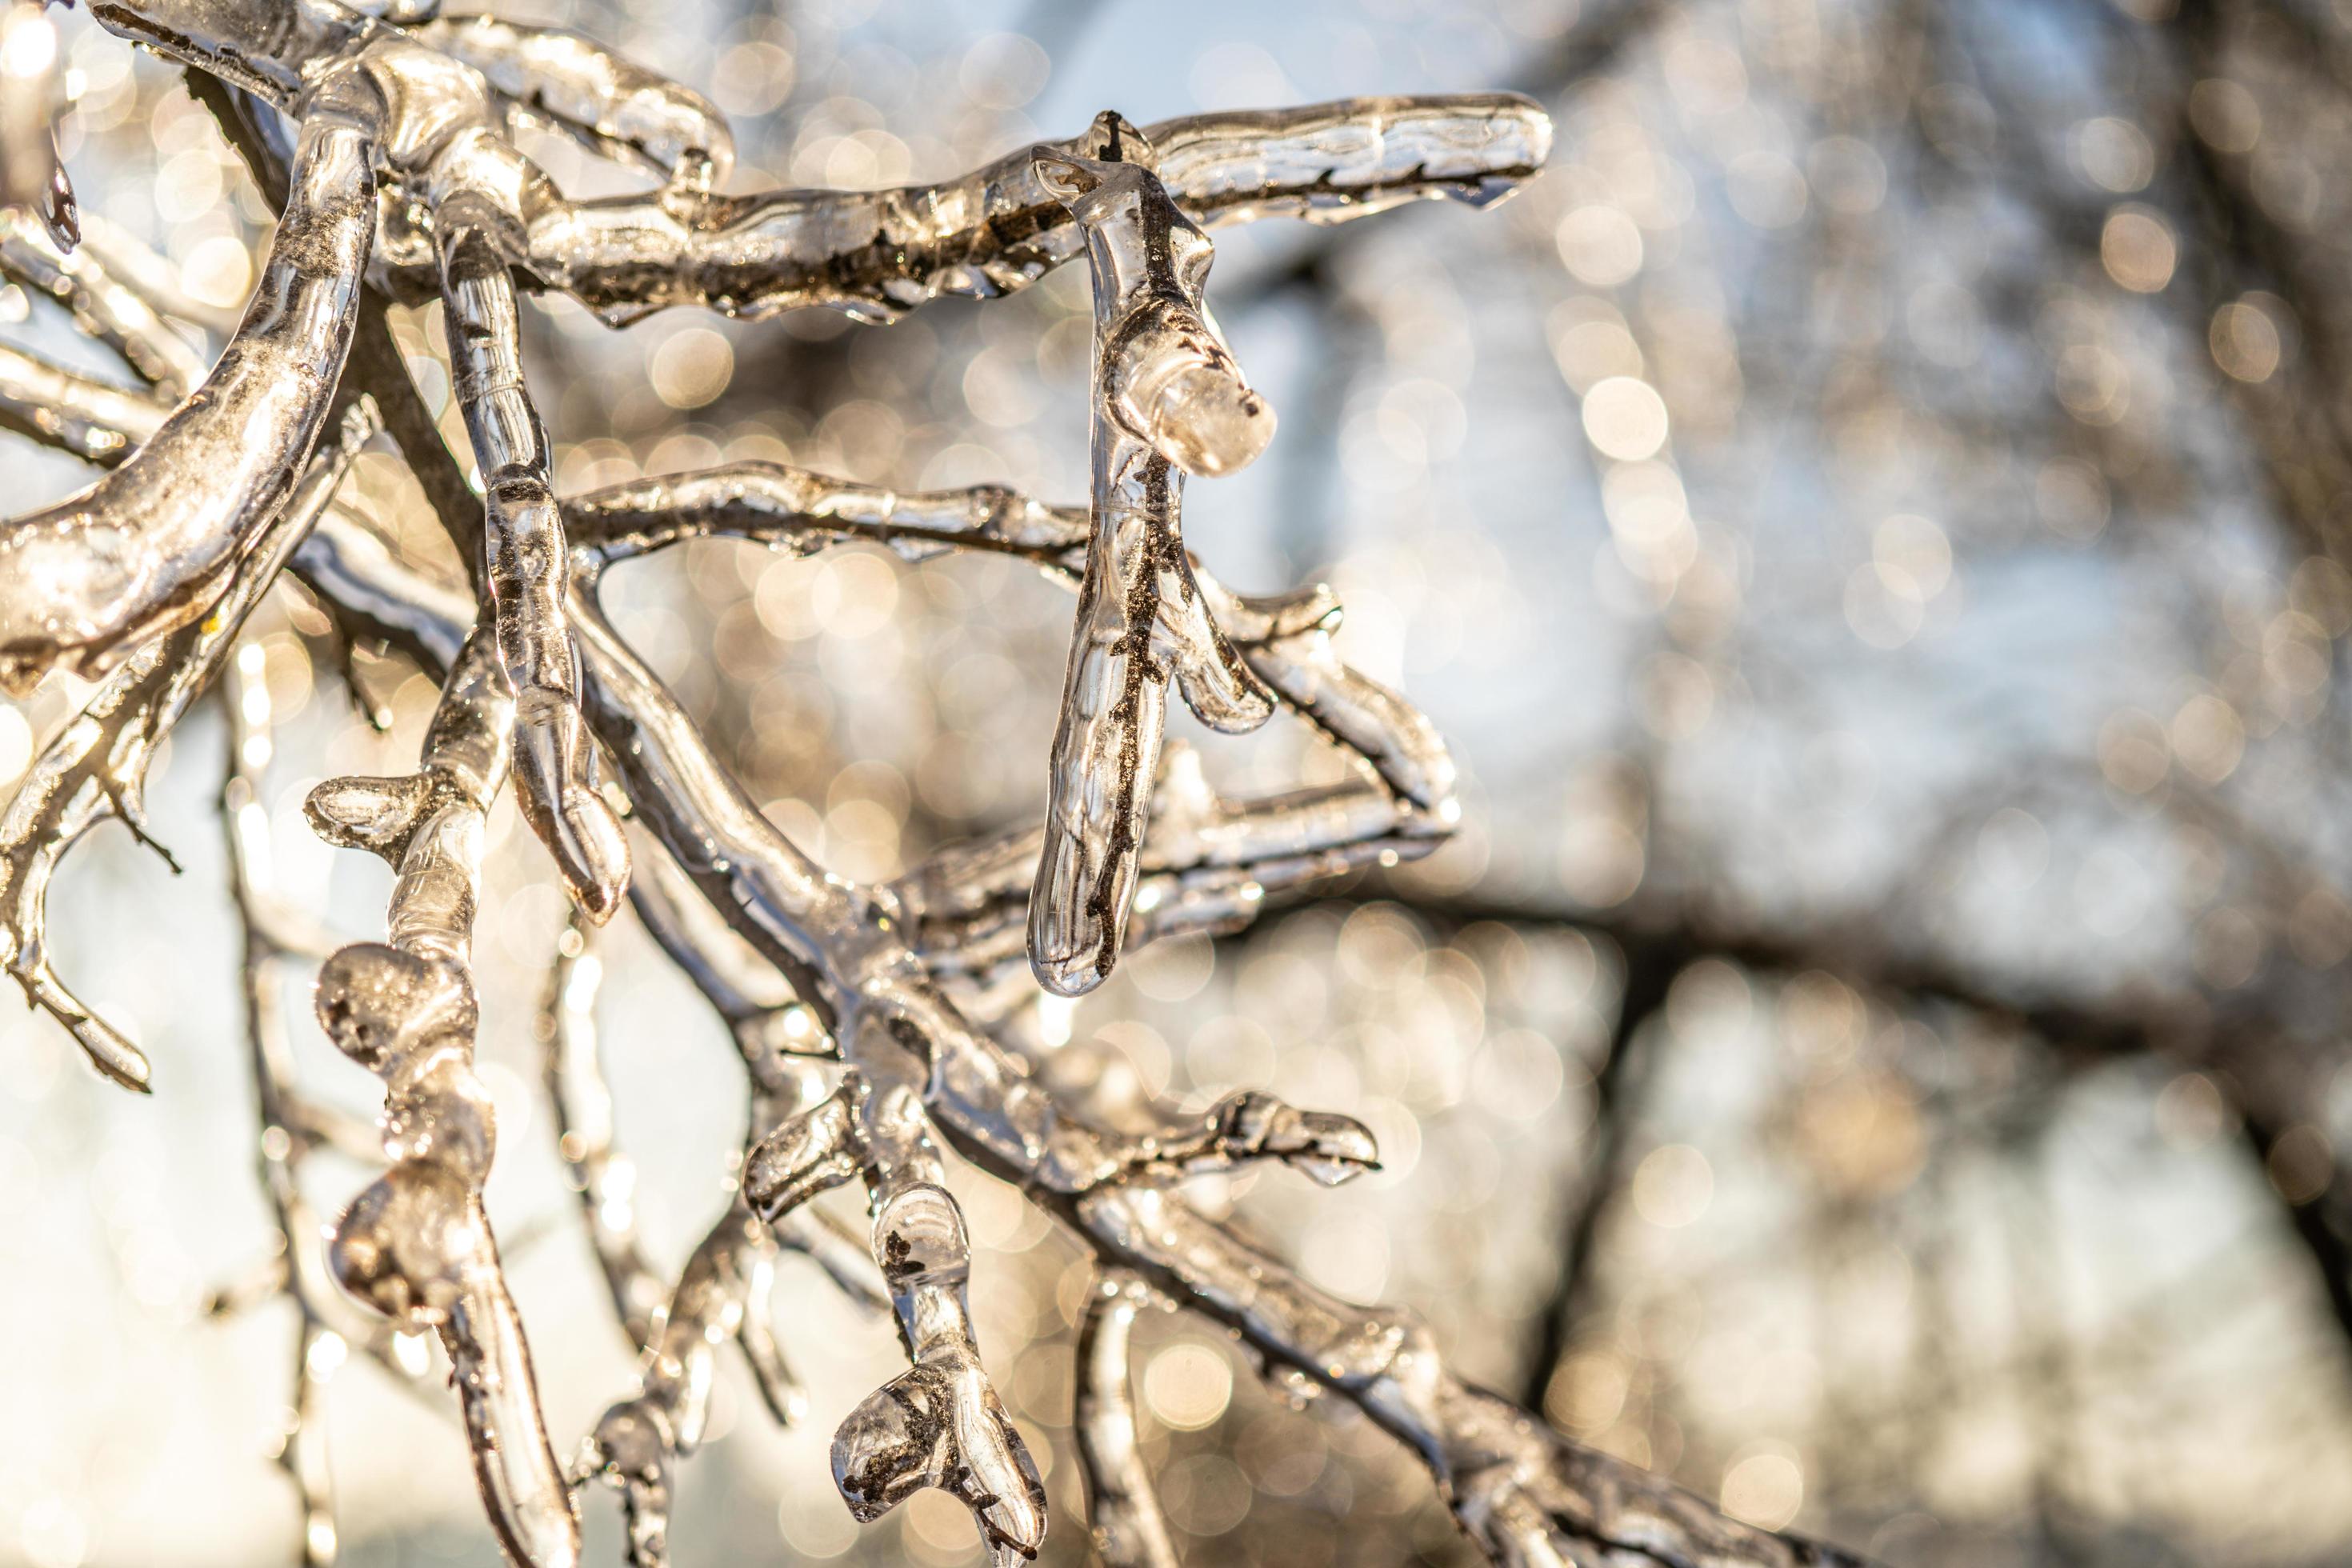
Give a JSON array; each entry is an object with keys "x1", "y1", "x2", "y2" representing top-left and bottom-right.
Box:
[{"x1": 1028, "y1": 138, "x2": 1274, "y2": 997}]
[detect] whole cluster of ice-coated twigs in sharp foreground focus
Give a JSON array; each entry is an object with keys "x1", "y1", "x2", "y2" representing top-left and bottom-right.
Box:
[{"x1": 0, "y1": 0, "x2": 1862, "y2": 1568}]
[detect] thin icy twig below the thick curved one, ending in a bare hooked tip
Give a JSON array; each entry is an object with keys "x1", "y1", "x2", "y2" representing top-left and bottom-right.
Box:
[{"x1": 0, "y1": 400, "x2": 376, "y2": 1090}]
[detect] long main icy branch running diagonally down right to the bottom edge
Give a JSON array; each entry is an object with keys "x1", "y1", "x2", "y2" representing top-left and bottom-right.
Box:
[{"x1": 586, "y1": 585, "x2": 1851, "y2": 1568}]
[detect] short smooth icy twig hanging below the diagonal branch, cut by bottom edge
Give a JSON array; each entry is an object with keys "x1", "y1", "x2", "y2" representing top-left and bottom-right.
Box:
[{"x1": 1070, "y1": 1272, "x2": 1178, "y2": 1568}]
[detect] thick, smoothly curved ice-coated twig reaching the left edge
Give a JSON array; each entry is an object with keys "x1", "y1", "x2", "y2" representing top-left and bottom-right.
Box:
[{"x1": 0, "y1": 122, "x2": 374, "y2": 694}]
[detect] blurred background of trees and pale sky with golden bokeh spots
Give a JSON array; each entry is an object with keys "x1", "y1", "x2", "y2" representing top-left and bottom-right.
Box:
[{"x1": 0, "y1": 0, "x2": 2352, "y2": 1568}]
